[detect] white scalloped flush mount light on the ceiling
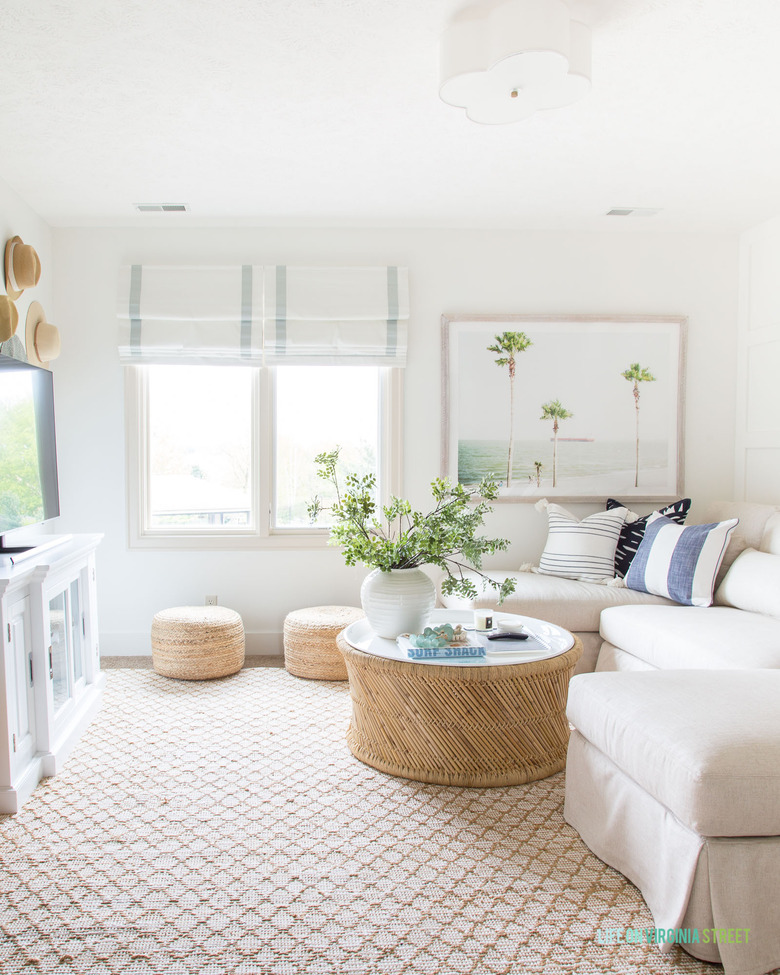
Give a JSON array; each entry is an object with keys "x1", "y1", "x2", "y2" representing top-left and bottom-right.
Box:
[{"x1": 439, "y1": 0, "x2": 590, "y2": 124}]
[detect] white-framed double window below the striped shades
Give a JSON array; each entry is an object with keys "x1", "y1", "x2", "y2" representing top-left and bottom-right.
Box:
[{"x1": 126, "y1": 365, "x2": 402, "y2": 548}]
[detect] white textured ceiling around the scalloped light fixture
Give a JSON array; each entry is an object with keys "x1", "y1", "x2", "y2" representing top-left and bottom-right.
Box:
[{"x1": 0, "y1": 0, "x2": 780, "y2": 231}]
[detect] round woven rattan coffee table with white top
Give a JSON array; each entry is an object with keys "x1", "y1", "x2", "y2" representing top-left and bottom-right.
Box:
[{"x1": 337, "y1": 610, "x2": 582, "y2": 787}]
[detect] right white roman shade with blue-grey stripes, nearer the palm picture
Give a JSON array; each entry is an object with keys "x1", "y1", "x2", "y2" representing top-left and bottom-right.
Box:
[{"x1": 264, "y1": 265, "x2": 409, "y2": 366}]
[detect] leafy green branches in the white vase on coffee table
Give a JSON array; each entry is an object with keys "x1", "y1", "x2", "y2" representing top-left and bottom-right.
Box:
[{"x1": 308, "y1": 447, "x2": 515, "y2": 603}]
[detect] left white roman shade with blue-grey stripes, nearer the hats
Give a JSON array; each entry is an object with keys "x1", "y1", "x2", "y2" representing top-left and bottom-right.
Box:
[{"x1": 117, "y1": 264, "x2": 263, "y2": 364}]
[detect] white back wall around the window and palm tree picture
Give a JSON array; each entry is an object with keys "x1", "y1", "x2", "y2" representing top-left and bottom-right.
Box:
[{"x1": 54, "y1": 228, "x2": 738, "y2": 654}]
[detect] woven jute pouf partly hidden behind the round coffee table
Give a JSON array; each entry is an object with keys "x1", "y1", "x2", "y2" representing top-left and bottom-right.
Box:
[{"x1": 284, "y1": 606, "x2": 366, "y2": 680}]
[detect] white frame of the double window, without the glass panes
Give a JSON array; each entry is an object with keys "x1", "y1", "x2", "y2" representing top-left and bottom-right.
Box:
[{"x1": 124, "y1": 365, "x2": 403, "y2": 551}]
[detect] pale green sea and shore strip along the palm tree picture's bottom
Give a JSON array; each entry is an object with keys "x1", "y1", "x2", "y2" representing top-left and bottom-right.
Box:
[{"x1": 458, "y1": 437, "x2": 669, "y2": 486}]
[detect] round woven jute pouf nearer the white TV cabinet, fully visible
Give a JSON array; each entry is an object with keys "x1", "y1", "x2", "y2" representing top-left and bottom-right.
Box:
[{"x1": 152, "y1": 606, "x2": 244, "y2": 680}]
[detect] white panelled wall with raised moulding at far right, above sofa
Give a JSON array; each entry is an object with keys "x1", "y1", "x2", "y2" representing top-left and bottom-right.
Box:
[{"x1": 735, "y1": 217, "x2": 780, "y2": 504}]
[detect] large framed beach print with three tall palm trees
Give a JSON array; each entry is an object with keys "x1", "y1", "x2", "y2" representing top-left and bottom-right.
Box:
[{"x1": 442, "y1": 315, "x2": 686, "y2": 502}]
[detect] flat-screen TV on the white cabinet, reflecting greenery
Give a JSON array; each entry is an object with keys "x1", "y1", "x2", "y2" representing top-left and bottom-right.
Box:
[{"x1": 0, "y1": 356, "x2": 60, "y2": 535}]
